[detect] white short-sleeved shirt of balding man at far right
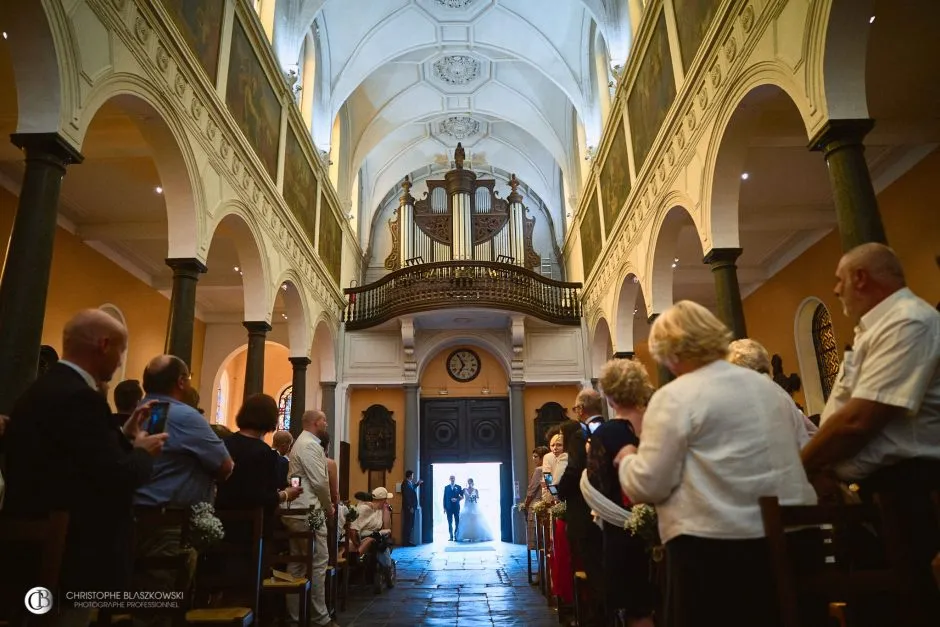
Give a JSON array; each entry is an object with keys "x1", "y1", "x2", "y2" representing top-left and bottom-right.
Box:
[{"x1": 820, "y1": 287, "x2": 940, "y2": 480}]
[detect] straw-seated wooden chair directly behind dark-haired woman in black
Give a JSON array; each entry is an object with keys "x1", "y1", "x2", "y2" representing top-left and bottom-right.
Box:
[{"x1": 186, "y1": 508, "x2": 264, "y2": 627}]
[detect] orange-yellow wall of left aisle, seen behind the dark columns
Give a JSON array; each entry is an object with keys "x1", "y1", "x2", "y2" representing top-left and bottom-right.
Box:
[{"x1": 0, "y1": 188, "x2": 207, "y2": 402}]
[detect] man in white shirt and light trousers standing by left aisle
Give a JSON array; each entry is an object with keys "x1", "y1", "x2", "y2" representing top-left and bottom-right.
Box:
[{"x1": 284, "y1": 409, "x2": 336, "y2": 625}]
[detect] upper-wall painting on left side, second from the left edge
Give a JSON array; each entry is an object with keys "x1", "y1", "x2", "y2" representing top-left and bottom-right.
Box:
[{"x1": 225, "y1": 15, "x2": 281, "y2": 179}]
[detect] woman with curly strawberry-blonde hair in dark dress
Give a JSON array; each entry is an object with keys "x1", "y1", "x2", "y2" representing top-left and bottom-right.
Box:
[{"x1": 581, "y1": 359, "x2": 655, "y2": 627}]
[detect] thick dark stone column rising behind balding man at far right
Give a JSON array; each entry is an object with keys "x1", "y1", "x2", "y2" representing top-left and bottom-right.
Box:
[{"x1": 810, "y1": 120, "x2": 888, "y2": 251}]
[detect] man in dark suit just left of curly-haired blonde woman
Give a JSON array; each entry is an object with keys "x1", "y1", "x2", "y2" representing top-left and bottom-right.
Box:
[{"x1": 558, "y1": 388, "x2": 604, "y2": 625}]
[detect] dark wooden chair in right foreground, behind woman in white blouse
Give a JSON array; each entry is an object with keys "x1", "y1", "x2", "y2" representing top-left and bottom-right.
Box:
[{"x1": 760, "y1": 497, "x2": 911, "y2": 627}]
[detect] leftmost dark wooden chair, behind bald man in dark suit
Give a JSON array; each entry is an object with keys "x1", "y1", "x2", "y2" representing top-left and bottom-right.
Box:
[{"x1": 0, "y1": 512, "x2": 69, "y2": 626}]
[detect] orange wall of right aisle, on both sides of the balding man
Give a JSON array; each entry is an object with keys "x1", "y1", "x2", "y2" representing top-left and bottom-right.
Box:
[{"x1": 744, "y1": 150, "x2": 940, "y2": 405}]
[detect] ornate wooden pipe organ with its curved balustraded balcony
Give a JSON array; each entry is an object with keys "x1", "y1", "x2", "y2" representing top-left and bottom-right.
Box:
[{"x1": 344, "y1": 143, "x2": 581, "y2": 330}]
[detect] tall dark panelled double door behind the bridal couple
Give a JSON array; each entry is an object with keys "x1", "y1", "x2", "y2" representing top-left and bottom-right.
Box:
[{"x1": 420, "y1": 398, "x2": 513, "y2": 542}]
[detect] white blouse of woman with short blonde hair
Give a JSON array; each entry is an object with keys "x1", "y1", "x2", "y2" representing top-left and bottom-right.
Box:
[{"x1": 619, "y1": 361, "x2": 816, "y2": 542}]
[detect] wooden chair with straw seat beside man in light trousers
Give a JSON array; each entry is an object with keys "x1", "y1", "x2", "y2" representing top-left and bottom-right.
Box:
[{"x1": 261, "y1": 507, "x2": 316, "y2": 627}]
